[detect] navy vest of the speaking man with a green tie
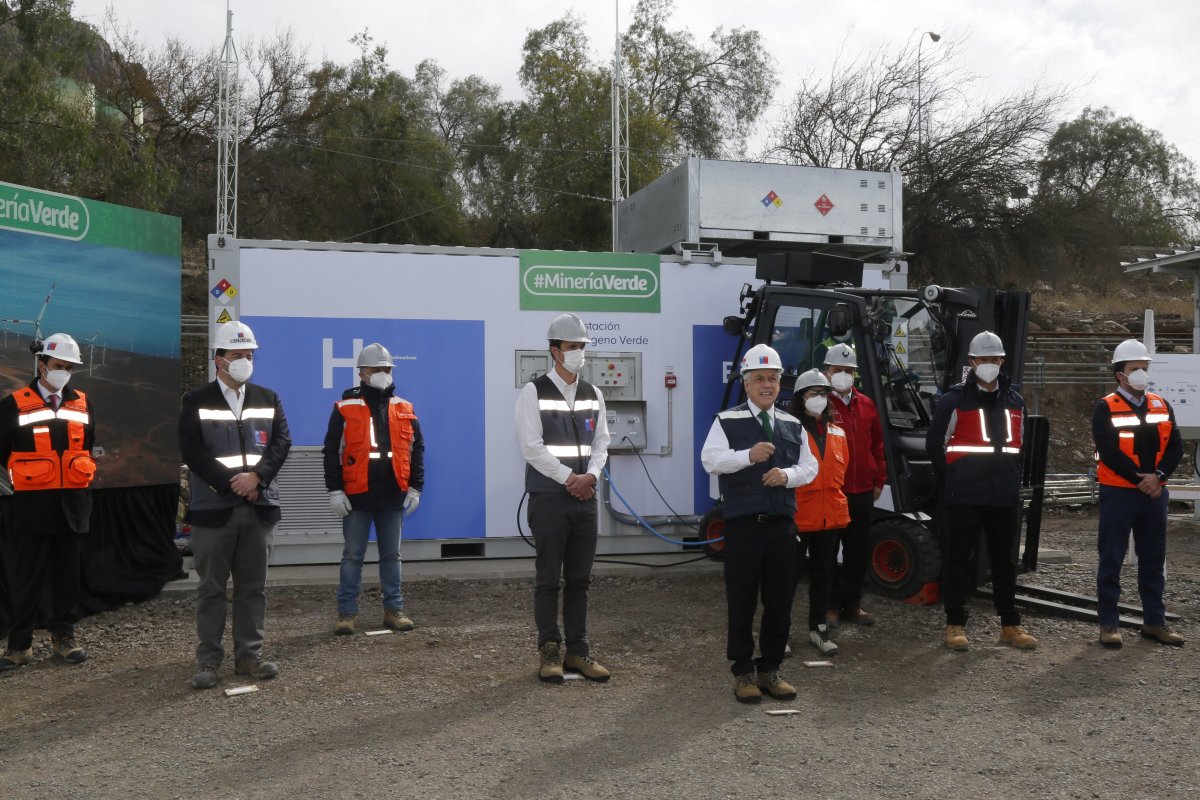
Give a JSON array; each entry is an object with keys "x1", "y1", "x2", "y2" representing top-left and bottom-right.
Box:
[{"x1": 716, "y1": 403, "x2": 805, "y2": 519}]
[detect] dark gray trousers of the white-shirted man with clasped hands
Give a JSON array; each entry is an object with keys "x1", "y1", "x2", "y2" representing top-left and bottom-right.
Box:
[{"x1": 529, "y1": 491, "x2": 599, "y2": 656}]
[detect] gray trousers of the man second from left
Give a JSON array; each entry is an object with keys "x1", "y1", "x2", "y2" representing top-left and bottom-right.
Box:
[{"x1": 192, "y1": 503, "x2": 275, "y2": 667}]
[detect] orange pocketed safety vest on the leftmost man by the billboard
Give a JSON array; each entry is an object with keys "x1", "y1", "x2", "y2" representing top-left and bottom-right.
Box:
[{"x1": 8, "y1": 386, "x2": 96, "y2": 492}]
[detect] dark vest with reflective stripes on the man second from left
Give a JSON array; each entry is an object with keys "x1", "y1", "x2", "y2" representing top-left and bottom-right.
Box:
[{"x1": 188, "y1": 384, "x2": 280, "y2": 511}]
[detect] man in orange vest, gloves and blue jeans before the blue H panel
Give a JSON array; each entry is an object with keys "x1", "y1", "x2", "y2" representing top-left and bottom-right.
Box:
[{"x1": 322, "y1": 343, "x2": 425, "y2": 636}]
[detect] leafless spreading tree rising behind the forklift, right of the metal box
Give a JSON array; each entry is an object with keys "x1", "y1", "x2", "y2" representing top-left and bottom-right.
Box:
[{"x1": 768, "y1": 42, "x2": 1066, "y2": 284}]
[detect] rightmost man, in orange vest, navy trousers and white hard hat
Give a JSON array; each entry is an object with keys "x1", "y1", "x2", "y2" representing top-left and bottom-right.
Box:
[{"x1": 1092, "y1": 339, "x2": 1183, "y2": 649}]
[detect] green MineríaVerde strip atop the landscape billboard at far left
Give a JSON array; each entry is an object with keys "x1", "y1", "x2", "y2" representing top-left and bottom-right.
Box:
[{"x1": 0, "y1": 182, "x2": 181, "y2": 258}]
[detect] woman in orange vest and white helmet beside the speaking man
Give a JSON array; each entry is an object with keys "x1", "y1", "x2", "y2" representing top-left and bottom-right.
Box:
[{"x1": 787, "y1": 369, "x2": 850, "y2": 656}]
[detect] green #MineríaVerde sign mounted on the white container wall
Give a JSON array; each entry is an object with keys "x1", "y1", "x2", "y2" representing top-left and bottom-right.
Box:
[{"x1": 521, "y1": 251, "x2": 661, "y2": 314}]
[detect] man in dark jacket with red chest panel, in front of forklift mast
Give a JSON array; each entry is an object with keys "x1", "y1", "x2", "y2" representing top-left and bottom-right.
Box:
[{"x1": 925, "y1": 331, "x2": 1038, "y2": 651}]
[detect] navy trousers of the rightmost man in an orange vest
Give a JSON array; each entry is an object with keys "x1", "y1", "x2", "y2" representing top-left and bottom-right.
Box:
[{"x1": 1096, "y1": 486, "x2": 1168, "y2": 627}]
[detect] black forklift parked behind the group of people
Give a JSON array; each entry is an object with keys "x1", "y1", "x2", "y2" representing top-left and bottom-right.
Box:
[{"x1": 701, "y1": 252, "x2": 1171, "y2": 625}]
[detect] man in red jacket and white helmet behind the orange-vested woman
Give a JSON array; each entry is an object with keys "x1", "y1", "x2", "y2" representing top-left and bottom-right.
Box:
[{"x1": 824, "y1": 342, "x2": 888, "y2": 625}]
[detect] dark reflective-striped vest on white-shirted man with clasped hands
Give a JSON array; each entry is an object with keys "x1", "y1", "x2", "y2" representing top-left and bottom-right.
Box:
[{"x1": 526, "y1": 375, "x2": 600, "y2": 492}]
